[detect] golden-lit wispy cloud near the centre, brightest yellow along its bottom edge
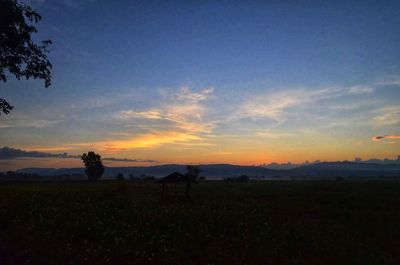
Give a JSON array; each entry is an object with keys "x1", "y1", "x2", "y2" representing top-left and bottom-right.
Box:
[{"x1": 107, "y1": 87, "x2": 215, "y2": 149}]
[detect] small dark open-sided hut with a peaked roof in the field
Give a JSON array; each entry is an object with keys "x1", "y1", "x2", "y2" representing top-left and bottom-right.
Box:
[{"x1": 158, "y1": 172, "x2": 190, "y2": 197}]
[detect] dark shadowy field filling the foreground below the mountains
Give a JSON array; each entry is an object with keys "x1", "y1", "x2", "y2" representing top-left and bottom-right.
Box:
[{"x1": 0, "y1": 181, "x2": 400, "y2": 265}]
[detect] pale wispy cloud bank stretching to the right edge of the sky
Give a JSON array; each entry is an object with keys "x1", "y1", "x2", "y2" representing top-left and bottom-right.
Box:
[{"x1": 232, "y1": 76, "x2": 400, "y2": 134}]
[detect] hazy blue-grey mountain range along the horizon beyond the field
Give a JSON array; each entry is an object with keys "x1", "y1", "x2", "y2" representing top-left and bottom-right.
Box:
[{"x1": 12, "y1": 162, "x2": 400, "y2": 178}]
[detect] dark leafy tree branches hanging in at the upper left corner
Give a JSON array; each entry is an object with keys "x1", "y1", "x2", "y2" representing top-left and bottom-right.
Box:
[{"x1": 0, "y1": 0, "x2": 52, "y2": 115}]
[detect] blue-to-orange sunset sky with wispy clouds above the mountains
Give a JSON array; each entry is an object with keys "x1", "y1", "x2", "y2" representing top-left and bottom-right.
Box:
[{"x1": 0, "y1": 0, "x2": 400, "y2": 169}]
